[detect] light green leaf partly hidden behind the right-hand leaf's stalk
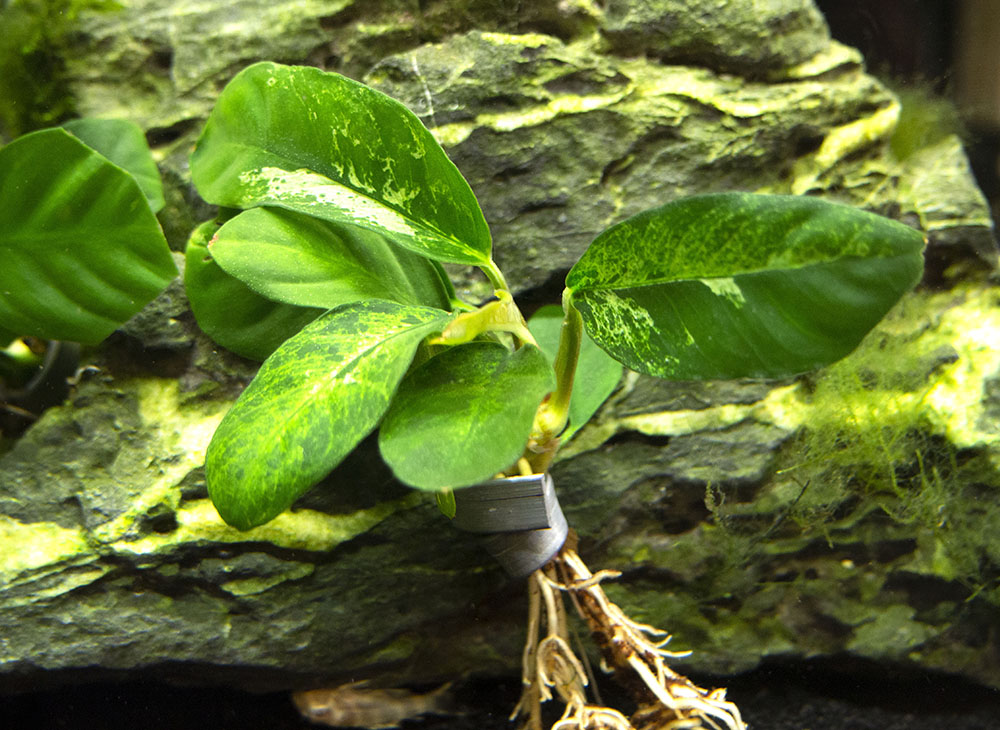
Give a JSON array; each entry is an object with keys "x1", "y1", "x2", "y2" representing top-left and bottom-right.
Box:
[{"x1": 528, "y1": 306, "x2": 622, "y2": 441}]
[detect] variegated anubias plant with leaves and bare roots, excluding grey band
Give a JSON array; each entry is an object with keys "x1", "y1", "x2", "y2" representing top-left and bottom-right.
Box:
[{"x1": 185, "y1": 63, "x2": 924, "y2": 728}]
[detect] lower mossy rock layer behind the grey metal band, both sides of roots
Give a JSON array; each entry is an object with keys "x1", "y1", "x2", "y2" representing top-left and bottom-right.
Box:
[{"x1": 0, "y1": 274, "x2": 1000, "y2": 689}]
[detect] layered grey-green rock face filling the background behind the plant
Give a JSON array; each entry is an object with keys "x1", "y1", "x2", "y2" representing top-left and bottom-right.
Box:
[{"x1": 0, "y1": 0, "x2": 1000, "y2": 688}]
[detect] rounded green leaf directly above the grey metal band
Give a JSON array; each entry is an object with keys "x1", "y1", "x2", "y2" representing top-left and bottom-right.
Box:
[{"x1": 379, "y1": 342, "x2": 555, "y2": 490}]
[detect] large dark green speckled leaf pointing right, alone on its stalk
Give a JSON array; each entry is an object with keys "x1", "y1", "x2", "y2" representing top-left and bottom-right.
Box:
[{"x1": 566, "y1": 193, "x2": 924, "y2": 379}]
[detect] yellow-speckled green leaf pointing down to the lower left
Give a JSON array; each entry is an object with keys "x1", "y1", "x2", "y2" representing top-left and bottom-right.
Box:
[{"x1": 205, "y1": 301, "x2": 451, "y2": 530}]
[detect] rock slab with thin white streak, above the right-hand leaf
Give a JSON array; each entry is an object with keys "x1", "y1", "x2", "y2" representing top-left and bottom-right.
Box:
[{"x1": 365, "y1": 32, "x2": 995, "y2": 298}]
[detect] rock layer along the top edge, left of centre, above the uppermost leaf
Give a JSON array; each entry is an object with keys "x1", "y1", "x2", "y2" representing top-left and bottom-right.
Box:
[{"x1": 65, "y1": 0, "x2": 597, "y2": 132}]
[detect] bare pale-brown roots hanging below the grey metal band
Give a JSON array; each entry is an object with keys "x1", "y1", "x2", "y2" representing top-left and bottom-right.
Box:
[{"x1": 511, "y1": 541, "x2": 746, "y2": 730}]
